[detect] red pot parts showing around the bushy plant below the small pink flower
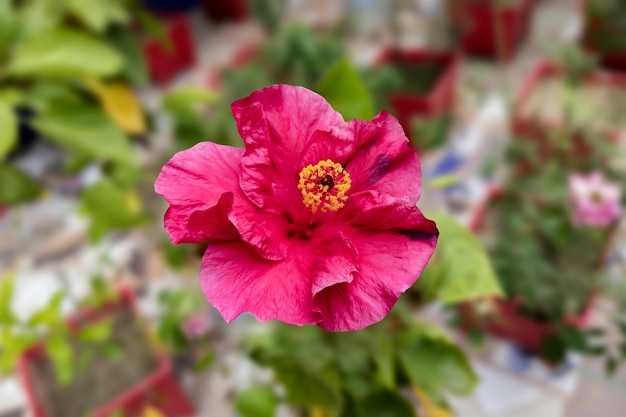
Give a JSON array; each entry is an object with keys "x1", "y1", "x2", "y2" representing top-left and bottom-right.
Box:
[{"x1": 458, "y1": 189, "x2": 593, "y2": 352}]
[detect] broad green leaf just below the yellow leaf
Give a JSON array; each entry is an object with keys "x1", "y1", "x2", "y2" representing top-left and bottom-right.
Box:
[{"x1": 31, "y1": 105, "x2": 137, "y2": 165}]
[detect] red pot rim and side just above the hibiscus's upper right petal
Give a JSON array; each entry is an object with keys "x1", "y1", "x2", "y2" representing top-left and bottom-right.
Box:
[{"x1": 378, "y1": 49, "x2": 461, "y2": 145}]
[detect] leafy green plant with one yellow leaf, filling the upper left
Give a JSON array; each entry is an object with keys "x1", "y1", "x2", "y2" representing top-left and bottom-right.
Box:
[{"x1": 0, "y1": 0, "x2": 148, "y2": 240}]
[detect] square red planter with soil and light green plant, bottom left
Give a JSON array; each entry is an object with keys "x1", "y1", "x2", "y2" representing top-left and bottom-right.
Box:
[{"x1": 0, "y1": 278, "x2": 194, "y2": 417}]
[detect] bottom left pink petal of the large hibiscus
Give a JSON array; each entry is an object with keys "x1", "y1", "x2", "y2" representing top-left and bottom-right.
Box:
[{"x1": 200, "y1": 242, "x2": 316, "y2": 325}]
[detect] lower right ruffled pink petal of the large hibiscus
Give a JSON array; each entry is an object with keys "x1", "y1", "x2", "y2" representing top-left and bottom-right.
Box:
[{"x1": 314, "y1": 229, "x2": 437, "y2": 331}]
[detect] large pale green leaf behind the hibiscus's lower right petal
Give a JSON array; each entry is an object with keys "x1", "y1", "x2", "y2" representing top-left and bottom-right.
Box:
[{"x1": 417, "y1": 213, "x2": 502, "y2": 303}]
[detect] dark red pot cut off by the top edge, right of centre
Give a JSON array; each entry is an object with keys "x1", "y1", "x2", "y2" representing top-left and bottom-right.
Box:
[{"x1": 461, "y1": 0, "x2": 535, "y2": 60}]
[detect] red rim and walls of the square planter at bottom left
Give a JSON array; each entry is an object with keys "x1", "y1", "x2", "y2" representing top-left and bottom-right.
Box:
[{"x1": 18, "y1": 290, "x2": 195, "y2": 417}]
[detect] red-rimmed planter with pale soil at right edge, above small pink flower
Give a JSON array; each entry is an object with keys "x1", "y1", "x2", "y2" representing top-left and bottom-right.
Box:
[{"x1": 512, "y1": 49, "x2": 626, "y2": 156}]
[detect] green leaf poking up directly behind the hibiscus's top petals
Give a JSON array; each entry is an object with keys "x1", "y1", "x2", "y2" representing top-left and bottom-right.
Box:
[{"x1": 316, "y1": 60, "x2": 374, "y2": 120}]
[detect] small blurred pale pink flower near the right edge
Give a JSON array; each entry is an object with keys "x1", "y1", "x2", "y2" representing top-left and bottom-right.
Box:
[{"x1": 569, "y1": 171, "x2": 622, "y2": 227}]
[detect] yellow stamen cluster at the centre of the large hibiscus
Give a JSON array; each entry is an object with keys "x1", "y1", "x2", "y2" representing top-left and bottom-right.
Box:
[{"x1": 298, "y1": 159, "x2": 352, "y2": 213}]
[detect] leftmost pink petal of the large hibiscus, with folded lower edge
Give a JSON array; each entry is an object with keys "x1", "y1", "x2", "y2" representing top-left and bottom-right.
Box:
[{"x1": 155, "y1": 142, "x2": 289, "y2": 260}]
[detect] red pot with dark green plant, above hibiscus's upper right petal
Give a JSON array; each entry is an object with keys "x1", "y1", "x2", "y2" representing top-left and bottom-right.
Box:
[{"x1": 365, "y1": 49, "x2": 460, "y2": 150}]
